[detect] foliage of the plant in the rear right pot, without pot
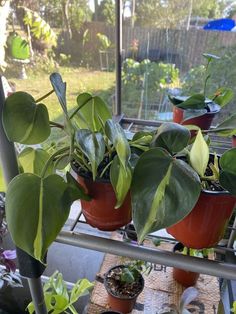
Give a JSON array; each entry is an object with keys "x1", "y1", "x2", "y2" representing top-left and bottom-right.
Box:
[{"x1": 169, "y1": 53, "x2": 234, "y2": 120}]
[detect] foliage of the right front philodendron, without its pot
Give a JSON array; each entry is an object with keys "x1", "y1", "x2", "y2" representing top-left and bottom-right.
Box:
[{"x1": 131, "y1": 123, "x2": 236, "y2": 242}]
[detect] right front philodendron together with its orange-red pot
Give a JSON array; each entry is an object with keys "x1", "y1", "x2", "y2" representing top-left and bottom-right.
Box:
[{"x1": 131, "y1": 123, "x2": 236, "y2": 249}]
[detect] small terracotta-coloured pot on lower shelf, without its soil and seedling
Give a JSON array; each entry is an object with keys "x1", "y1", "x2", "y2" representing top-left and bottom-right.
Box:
[{"x1": 104, "y1": 265, "x2": 144, "y2": 314}]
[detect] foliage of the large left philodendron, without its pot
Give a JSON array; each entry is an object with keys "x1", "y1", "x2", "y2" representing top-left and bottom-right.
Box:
[{"x1": 2, "y1": 73, "x2": 152, "y2": 262}]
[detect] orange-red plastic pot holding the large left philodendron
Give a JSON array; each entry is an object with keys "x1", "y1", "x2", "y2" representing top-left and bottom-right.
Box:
[{"x1": 77, "y1": 175, "x2": 131, "y2": 231}]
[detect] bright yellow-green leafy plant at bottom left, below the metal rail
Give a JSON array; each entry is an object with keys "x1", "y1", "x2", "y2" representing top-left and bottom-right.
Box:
[{"x1": 27, "y1": 271, "x2": 94, "y2": 314}]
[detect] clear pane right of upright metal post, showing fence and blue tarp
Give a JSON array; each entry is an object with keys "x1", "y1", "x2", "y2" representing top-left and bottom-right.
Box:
[{"x1": 122, "y1": 0, "x2": 236, "y2": 123}]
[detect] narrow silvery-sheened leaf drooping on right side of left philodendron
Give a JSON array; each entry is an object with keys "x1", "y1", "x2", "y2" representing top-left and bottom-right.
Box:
[{"x1": 105, "y1": 119, "x2": 131, "y2": 169}]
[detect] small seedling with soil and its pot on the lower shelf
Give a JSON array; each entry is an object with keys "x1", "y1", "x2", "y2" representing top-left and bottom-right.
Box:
[{"x1": 104, "y1": 261, "x2": 150, "y2": 313}]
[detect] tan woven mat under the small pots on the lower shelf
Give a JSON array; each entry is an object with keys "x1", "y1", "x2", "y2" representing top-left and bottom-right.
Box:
[{"x1": 87, "y1": 233, "x2": 220, "y2": 314}]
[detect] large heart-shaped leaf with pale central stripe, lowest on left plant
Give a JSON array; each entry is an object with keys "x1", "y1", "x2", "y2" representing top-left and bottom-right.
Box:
[{"x1": 6, "y1": 173, "x2": 83, "y2": 262}]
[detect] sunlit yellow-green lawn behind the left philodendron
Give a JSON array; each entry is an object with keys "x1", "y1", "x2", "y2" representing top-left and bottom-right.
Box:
[{"x1": 11, "y1": 67, "x2": 115, "y2": 120}]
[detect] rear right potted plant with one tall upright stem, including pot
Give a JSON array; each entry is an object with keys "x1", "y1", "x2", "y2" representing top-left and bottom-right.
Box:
[{"x1": 169, "y1": 53, "x2": 233, "y2": 130}]
